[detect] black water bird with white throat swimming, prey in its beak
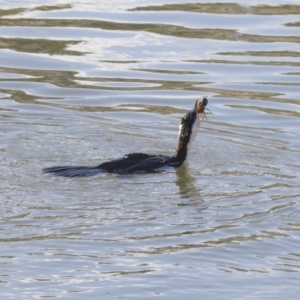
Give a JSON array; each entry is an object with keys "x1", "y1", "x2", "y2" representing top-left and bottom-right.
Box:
[{"x1": 43, "y1": 98, "x2": 208, "y2": 177}]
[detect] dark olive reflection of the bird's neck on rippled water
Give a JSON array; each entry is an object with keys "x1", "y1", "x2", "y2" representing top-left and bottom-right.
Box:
[{"x1": 175, "y1": 163, "x2": 200, "y2": 198}]
